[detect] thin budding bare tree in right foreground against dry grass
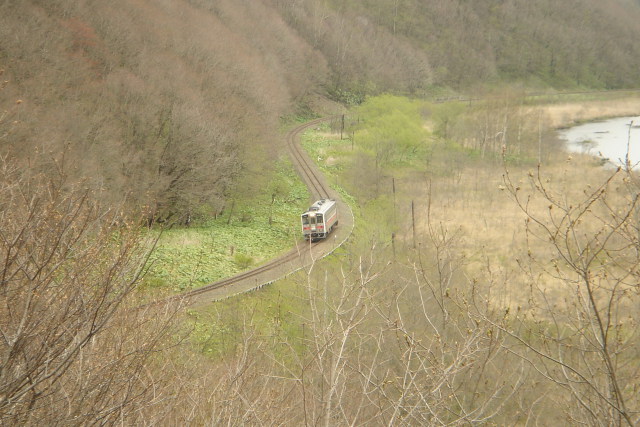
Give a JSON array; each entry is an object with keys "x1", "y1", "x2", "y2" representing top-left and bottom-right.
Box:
[{"x1": 496, "y1": 162, "x2": 640, "y2": 425}]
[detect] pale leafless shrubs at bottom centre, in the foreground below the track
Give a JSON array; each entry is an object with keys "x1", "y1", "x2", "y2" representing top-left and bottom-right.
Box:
[{"x1": 184, "y1": 239, "x2": 528, "y2": 425}]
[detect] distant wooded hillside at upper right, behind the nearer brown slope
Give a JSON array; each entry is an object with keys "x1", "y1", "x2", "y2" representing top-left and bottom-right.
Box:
[{"x1": 276, "y1": 0, "x2": 640, "y2": 93}]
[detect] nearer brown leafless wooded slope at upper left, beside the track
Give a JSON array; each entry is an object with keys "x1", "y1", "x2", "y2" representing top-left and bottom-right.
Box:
[{"x1": 0, "y1": 0, "x2": 325, "y2": 224}]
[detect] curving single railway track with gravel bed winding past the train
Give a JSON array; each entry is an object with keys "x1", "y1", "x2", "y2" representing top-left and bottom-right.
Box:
[{"x1": 171, "y1": 116, "x2": 354, "y2": 305}]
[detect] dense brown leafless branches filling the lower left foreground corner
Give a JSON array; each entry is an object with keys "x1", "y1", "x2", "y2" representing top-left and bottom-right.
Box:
[{"x1": 0, "y1": 158, "x2": 180, "y2": 425}]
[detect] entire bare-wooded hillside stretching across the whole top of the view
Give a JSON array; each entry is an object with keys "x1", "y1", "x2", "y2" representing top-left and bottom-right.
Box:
[{"x1": 0, "y1": 0, "x2": 640, "y2": 221}]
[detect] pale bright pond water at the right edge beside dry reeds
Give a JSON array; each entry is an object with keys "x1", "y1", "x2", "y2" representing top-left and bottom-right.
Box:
[{"x1": 558, "y1": 116, "x2": 640, "y2": 166}]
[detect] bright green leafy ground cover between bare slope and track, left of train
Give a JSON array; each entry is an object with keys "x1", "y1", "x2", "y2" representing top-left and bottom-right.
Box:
[{"x1": 144, "y1": 159, "x2": 309, "y2": 292}]
